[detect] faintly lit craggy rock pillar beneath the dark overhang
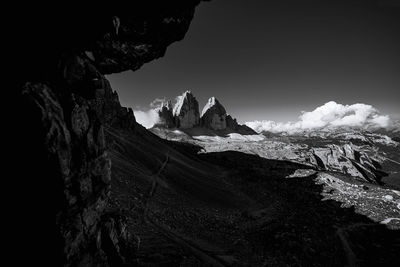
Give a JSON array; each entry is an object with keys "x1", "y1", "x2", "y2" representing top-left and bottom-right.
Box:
[{"x1": 23, "y1": 80, "x2": 134, "y2": 266}]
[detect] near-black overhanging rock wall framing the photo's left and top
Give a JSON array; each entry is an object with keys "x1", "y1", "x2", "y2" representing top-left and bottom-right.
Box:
[{"x1": 12, "y1": 0, "x2": 203, "y2": 266}]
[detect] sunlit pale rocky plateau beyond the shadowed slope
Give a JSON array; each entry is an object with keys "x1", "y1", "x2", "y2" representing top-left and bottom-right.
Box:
[{"x1": 192, "y1": 130, "x2": 400, "y2": 229}]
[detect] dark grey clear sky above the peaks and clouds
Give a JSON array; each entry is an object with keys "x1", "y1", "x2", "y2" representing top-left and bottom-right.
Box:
[{"x1": 107, "y1": 0, "x2": 400, "y2": 123}]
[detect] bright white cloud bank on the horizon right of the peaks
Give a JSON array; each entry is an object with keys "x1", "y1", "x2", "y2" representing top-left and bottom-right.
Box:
[{"x1": 246, "y1": 101, "x2": 390, "y2": 133}]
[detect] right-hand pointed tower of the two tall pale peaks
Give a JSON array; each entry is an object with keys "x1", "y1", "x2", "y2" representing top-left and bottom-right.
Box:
[{"x1": 201, "y1": 97, "x2": 227, "y2": 130}]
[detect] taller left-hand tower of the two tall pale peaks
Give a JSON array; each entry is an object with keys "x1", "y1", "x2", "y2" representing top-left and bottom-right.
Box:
[{"x1": 173, "y1": 91, "x2": 200, "y2": 129}]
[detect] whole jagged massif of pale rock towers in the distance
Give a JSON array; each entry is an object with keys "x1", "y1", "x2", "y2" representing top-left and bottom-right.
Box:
[{"x1": 153, "y1": 91, "x2": 256, "y2": 135}]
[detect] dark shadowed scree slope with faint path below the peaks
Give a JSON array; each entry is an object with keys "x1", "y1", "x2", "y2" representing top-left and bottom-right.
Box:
[{"x1": 106, "y1": 126, "x2": 400, "y2": 266}]
